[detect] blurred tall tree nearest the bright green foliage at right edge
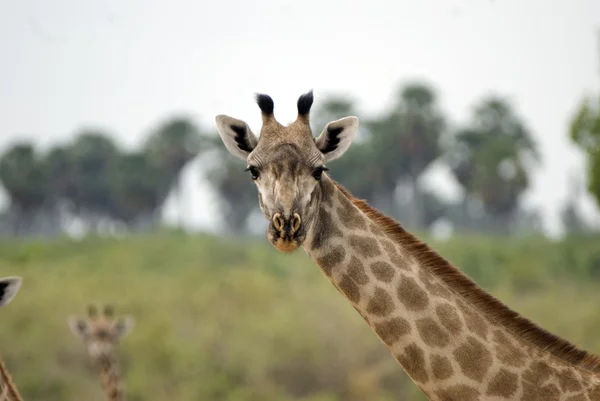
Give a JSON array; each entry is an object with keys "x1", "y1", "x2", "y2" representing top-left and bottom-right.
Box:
[{"x1": 448, "y1": 97, "x2": 540, "y2": 232}]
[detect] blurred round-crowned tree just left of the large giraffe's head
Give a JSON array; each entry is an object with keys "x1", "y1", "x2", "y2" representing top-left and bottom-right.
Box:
[{"x1": 145, "y1": 117, "x2": 201, "y2": 225}]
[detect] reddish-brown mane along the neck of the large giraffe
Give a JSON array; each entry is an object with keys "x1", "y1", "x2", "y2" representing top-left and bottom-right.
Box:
[{"x1": 333, "y1": 181, "x2": 600, "y2": 373}]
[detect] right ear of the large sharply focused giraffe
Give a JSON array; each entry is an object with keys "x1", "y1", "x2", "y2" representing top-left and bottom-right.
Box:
[{"x1": 315, "y1": 117, "x2": 358, "y2": 162}]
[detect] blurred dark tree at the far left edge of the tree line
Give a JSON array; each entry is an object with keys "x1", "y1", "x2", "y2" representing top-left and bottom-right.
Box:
[{"x1": 0, "y1": 143, "x2": 48, "y2": 235}]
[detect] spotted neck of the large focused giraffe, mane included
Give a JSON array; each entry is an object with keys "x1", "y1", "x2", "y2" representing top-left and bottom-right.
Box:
[{"x1": 304, "y1": 177, "x2": 600, "y2": 401}]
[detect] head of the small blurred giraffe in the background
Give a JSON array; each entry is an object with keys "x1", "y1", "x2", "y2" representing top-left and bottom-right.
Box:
[{"x1": 68, "y1": 305, "x2": 135, "y2": 359}]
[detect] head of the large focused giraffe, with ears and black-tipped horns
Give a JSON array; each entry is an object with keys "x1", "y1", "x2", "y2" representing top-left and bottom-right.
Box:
[{"x1": 216, "y1": 91, "x2": 358, "y2": 252}]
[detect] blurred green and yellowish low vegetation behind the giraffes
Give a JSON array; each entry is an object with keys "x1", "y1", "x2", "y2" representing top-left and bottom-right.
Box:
[{"x1": 0, "y1": 234, "x2": 600, "y2": 401}]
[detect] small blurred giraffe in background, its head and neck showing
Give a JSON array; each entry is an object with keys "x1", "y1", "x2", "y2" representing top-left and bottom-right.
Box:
[{"x1": 67, "y1": 305, "x2": 135, "y2": 401}]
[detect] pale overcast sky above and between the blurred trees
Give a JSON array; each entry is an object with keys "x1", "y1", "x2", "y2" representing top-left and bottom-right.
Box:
[{"x1": 0, "y1": 0, "x2": 600, "y2": 238}]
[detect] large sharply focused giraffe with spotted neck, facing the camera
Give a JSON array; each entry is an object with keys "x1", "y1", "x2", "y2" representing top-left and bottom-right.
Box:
[{"x1": 215, "y1": 90, "x2": 600, "y2": 401}]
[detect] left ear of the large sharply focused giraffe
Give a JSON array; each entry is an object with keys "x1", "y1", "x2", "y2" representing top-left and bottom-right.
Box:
[{"x1": 215, "y1": 114, "x2": 258, "y2": 161}]
